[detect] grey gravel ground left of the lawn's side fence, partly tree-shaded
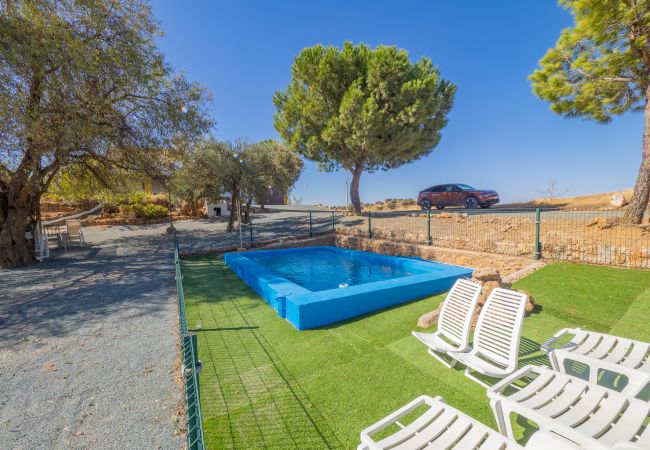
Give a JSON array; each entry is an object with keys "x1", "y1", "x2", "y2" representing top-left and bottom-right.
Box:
[{"x1": 0, "y1": 227, "x2": 184, "y2": 449}]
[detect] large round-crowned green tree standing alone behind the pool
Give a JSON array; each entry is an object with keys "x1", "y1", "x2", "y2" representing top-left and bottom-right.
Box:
[{"x1": 274, "y1": 42, "x2": 456, "y2": 213}]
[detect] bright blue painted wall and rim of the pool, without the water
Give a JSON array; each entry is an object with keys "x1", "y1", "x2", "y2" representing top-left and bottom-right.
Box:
[{"x1": 224, "y1": 246, "x2": 473, "y2": 330}]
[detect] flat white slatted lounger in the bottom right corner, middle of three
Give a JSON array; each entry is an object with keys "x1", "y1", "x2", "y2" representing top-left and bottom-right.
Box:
[{"x1": 488, "y1": 366, "x2": 650, "y2": 449}]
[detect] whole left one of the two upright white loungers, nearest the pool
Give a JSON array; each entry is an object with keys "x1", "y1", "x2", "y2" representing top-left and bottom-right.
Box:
[{"x1": 413, "y1": 279, "x2": 481, "y2": 367}]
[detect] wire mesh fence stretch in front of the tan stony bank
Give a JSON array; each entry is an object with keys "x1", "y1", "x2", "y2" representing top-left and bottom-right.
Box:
[{"x1": 337, "y1": 208, "x2": 650, "y2": 268}]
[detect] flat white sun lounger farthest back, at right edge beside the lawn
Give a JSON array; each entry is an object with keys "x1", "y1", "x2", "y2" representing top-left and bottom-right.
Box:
[{"x1": 541, "y1": 328, "x2": 650, "y2": 397}]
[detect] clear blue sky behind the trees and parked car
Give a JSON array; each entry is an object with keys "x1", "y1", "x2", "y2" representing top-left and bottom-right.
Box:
[{"x1": 153, "y1": 0, "x2": 643, "y2": 205}]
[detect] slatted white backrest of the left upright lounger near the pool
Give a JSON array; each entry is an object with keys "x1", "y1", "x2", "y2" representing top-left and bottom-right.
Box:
[{"x1": 438, "y1": 278, "x2": 481, "y2": 347}]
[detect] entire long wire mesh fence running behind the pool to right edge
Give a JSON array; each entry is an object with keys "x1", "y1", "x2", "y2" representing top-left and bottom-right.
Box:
[{"x1": 172, "y1": 208, "x2": 650, "y2": 268}]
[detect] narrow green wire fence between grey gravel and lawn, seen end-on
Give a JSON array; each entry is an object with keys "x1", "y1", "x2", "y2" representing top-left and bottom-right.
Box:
[{"x1": 174, "y1": 232, "x2": 205, "y2": 450}]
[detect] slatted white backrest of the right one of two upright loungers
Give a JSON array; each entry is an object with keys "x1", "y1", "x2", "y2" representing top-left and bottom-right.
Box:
[{"x1": 472, "y1": 288, "x2": 528, "y2": 370}]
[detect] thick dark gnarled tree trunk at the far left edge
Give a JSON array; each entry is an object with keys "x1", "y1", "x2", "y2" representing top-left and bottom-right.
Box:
[{"x1": 0, "y1": 191, "x2": 41, "y2": 268}]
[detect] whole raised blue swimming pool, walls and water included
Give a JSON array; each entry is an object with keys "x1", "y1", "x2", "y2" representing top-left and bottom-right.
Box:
[{"x1": 224, "y1": 246, "x2": 472, "y2": 330}]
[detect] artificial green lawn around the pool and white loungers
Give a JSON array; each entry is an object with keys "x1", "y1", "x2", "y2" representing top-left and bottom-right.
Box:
[{"x1": 183, "y1": 256, "x2": 650, "y2": 449}]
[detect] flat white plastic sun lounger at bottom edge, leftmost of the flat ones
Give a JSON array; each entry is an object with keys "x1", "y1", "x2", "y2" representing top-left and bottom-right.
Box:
[{"x1": 357, "y1": 395, "x2": 578, "y2": 450}]
